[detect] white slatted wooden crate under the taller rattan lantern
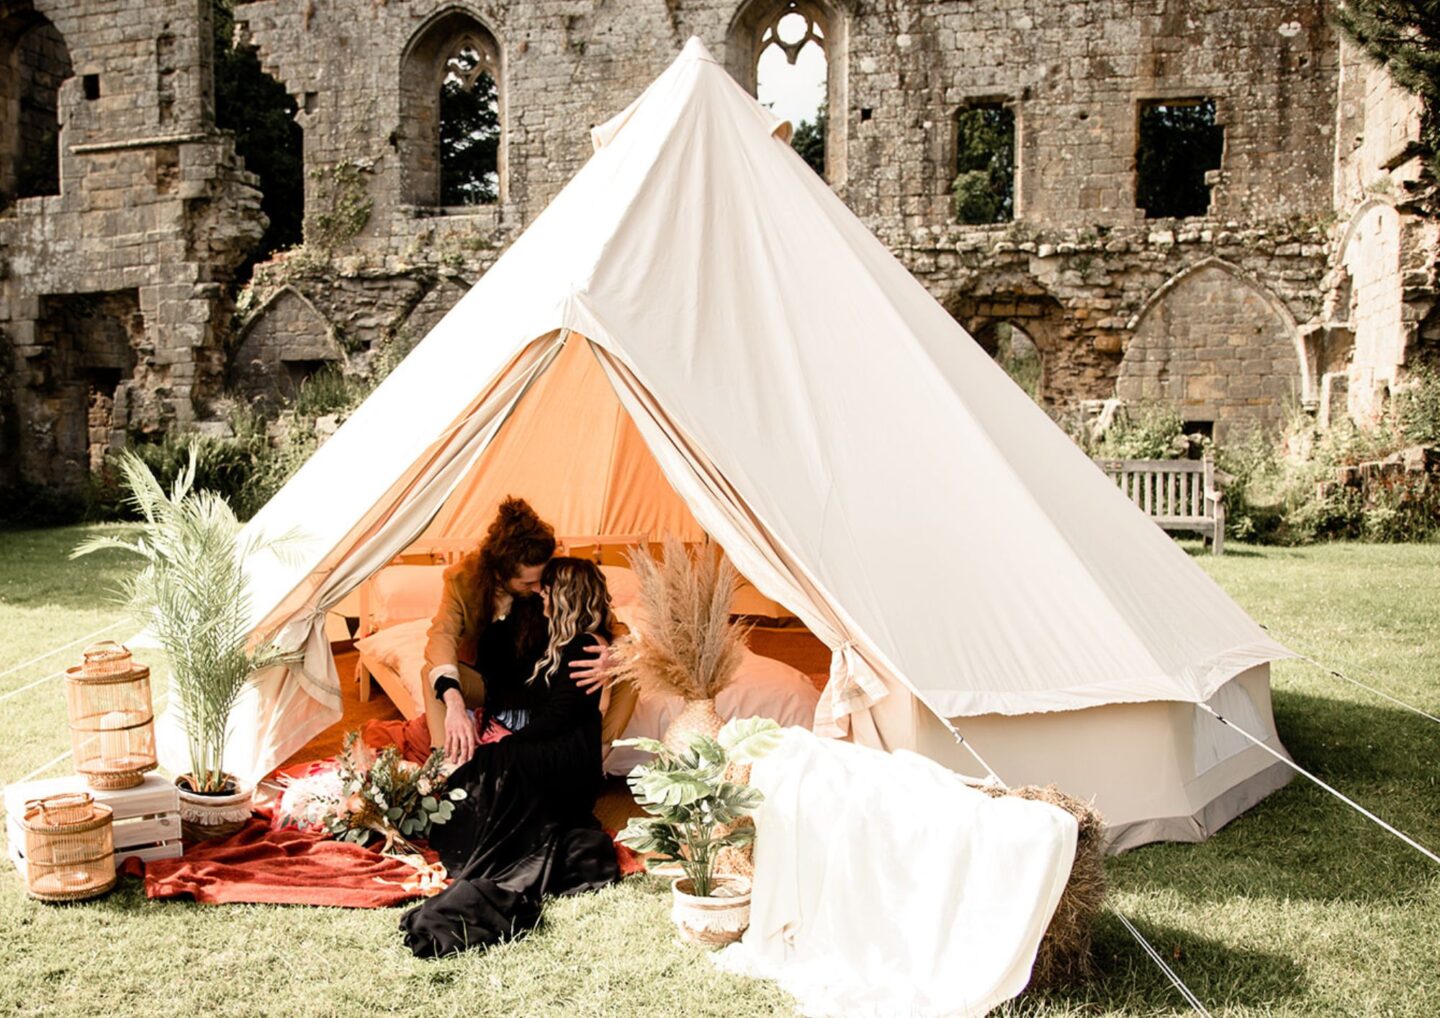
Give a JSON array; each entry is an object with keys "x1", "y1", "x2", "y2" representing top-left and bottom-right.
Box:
[{"x1": 4, "y1": 775, "x2": 181, "y2": 877}]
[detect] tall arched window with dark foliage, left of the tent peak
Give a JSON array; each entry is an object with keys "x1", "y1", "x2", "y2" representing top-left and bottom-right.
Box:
[{"x1": 393, "y1": 10, "x2": 505, "y2": 209}]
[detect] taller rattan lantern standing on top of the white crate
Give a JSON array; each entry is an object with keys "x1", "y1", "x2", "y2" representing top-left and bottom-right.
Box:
[{"x1": 65, "y1": 641, "x2": 156, "y2": 789}]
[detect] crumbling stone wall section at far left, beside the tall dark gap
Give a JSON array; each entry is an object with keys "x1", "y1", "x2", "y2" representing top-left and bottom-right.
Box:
[{"x1": 0, "y1": 0, "x2": 265, "y2": 488}]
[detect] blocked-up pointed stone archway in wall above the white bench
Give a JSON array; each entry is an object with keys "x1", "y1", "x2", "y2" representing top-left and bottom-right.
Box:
[{"x1": 1115, "y1": 258, "x2": 1312, "y2": 439}]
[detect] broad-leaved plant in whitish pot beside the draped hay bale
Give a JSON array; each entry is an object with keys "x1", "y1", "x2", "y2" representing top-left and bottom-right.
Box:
[{"x1": 616, "y1": 717, "x2": 780, "y2": 946}]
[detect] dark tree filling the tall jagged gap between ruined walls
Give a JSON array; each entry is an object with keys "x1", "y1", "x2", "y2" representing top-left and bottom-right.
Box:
[{"x1": 212, "y1": 0, "x2": 305, "y2": 276}]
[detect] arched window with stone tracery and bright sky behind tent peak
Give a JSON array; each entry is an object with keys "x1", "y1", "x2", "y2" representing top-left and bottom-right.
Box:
[{"x1": 727, "y1": 0, "x2": 845, "y2": 184}]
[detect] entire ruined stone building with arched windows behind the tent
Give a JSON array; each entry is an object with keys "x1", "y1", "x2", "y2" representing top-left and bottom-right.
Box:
[{"x1": 0, "y1": 0, "x2": 1437, "y2": 498}]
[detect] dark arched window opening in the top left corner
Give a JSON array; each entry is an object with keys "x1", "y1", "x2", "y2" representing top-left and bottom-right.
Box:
[{"x1": 0, "y1": 12, "x2": 75, "y2": 204}]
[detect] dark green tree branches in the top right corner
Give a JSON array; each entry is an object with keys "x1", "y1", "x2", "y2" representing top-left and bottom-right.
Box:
[{"x1": 1331, "y1": 0, "x2": 1440, "y2": 190}]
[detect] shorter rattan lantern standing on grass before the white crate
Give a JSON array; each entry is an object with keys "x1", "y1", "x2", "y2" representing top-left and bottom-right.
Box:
[{"x1": 20, "y1": 792, "x2": 115, "y2": 901}]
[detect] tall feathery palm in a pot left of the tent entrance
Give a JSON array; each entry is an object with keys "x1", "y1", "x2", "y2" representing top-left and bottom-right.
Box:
[{"x1": 71, "y1": 446, "x2": 292, "y2": 841}]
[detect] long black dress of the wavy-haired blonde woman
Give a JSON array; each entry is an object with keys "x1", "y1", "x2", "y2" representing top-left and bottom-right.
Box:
[{"x1": 400, "y1": 634, "x2": 619, "y2": 958}]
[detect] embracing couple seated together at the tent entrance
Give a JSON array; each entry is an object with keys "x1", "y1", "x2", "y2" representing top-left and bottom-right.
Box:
[{"x1": 400, "y1": 498, "x2": 635, "y2": 956}]
